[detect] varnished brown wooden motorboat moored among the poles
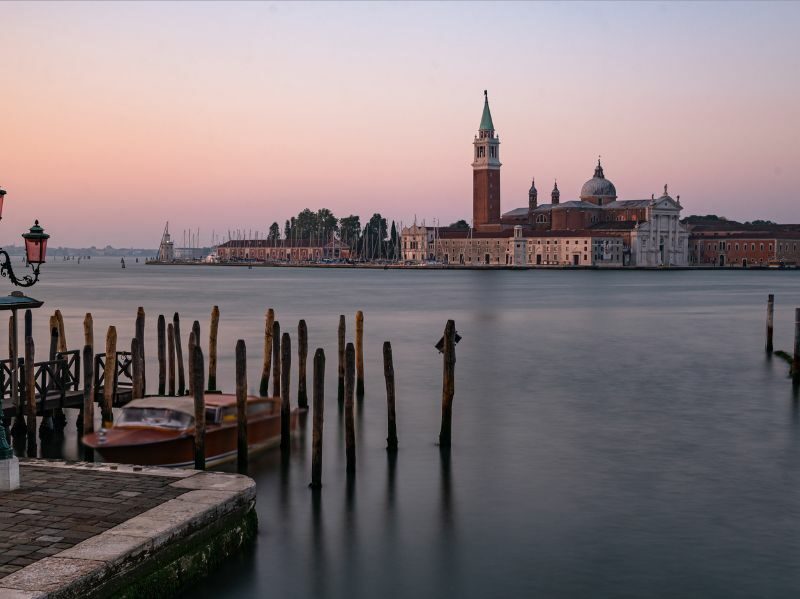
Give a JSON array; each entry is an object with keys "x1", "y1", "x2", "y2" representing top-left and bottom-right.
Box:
[{"x1": 83, "y1": 394, "x2": 298, "y2": 468}]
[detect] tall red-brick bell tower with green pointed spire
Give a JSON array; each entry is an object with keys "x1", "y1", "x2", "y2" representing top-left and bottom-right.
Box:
[{"x1": 472, "y1": 90, "x2": 501, "y2": 228}]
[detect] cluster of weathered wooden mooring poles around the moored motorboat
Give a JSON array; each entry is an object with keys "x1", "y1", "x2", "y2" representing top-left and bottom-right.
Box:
[{"x1": 1, "y1": 304, "x2": 456, "y2": 488}]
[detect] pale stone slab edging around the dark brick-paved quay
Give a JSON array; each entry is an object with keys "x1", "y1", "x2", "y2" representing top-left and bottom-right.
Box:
[{"x1": 0, "y1": 459, "x2": 258, "y2": 599}]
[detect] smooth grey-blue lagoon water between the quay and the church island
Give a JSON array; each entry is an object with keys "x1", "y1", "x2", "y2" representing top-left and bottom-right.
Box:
[{"x1": 9, "y1": 259, "x2": 800, "y2": 599}]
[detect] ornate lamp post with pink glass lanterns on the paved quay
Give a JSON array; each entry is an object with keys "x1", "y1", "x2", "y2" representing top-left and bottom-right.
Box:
[{"x1": 0, "y1": 189, "x2": 50, "y2": 491}]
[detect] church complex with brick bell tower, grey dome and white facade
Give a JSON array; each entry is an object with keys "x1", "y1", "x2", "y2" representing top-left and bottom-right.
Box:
[{"x1": 402, "y1": 91, "x2": 689, "y2": 266}]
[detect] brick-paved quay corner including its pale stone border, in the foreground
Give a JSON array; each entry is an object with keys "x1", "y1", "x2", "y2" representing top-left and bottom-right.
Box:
[{"x1": 0, "y1": 460, "x2": 256, "y2": 599}]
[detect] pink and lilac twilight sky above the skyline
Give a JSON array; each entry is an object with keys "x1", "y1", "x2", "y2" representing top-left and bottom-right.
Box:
[{"x1": 0, "y1": 2, "x2": 800, "y2": 247}]
